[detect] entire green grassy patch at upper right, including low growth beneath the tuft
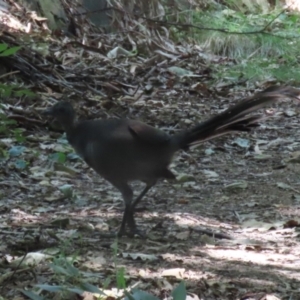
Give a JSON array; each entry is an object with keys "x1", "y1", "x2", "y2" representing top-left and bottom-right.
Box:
[{"x1": 165, "y1": 4, "x2": 300, "y2": 83}]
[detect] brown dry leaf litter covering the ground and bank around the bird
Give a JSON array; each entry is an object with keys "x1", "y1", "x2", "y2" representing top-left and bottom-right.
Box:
[{"x1": 0, "y1": 1, "x2": 300, "y2": 300}]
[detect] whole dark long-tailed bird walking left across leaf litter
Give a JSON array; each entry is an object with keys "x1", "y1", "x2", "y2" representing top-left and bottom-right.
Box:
[{"x1": 45, "y1": 86, "x2": 299, "y2": 235}]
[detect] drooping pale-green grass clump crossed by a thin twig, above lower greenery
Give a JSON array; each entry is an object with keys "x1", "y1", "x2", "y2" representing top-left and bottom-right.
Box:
[{"x1": 172, "y1": 9, "x2": 300, "y2": 58}]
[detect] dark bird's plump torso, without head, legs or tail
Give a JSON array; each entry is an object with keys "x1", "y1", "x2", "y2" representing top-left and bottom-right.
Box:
[{"x1": 67, "y1": 119, "x2": 178, "y2": 185}]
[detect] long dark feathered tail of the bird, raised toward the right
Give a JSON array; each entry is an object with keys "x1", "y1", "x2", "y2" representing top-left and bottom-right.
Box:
[{"x1": 175, "y1": 86, "x2": 300, "y2": 149}]
